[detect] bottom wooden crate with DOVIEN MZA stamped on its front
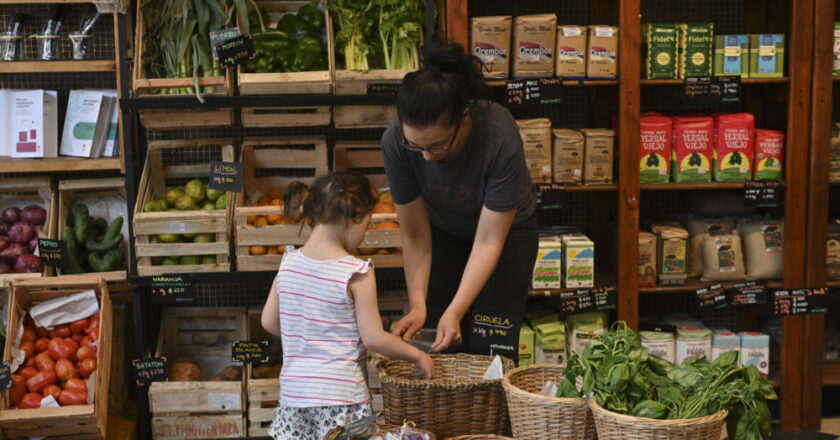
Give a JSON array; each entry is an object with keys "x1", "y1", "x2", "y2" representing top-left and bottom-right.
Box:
[{"x1": 149, "y1": 307, "x2": 248, "y2": 439}]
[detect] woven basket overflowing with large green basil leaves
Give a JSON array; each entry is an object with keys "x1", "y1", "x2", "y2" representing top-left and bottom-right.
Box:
[{"x1": 589, "y1": 399, "x2": 727, "y2": 440}]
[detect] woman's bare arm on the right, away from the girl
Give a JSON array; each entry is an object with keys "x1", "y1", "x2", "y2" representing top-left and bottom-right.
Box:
[{"x1": 432, "y1": 206, "x2": 516, "y2": 351}]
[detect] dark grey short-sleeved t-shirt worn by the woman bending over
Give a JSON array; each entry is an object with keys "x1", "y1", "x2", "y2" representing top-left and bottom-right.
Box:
[{"x1": 382, "y1": 101, "x2": 537, "y2": 240}]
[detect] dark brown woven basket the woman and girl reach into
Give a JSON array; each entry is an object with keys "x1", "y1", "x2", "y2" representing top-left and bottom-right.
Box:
[{"x1": 377, "y1": 353, "x2": 514, "y2": 438}]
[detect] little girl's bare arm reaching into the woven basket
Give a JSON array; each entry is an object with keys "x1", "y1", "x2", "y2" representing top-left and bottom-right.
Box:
[{"x1": 349, "y1": 269, "x2": 434, "y2": 379}]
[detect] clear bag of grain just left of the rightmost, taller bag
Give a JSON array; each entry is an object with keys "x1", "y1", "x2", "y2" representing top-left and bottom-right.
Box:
[{"x1": 700, "y1": 230, "x2": 746, "y2": 281}]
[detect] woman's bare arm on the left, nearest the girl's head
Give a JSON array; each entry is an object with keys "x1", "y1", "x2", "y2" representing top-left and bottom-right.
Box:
[{"x1": 394, "y1": 196, "x2": 432, "y2": 341}]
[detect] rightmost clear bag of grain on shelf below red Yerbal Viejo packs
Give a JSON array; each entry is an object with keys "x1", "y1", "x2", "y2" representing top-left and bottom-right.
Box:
[{"x1": 739, "y1": 220, "x2": 785, "y2": 280}]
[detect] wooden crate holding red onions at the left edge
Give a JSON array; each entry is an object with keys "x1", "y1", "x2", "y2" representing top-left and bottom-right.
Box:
[{"x1": 0, "y1": 177, "x2": 58, "y2": 287}]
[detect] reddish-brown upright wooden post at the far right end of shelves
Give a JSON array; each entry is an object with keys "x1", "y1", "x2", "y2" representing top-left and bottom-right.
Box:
[{"x1": 802, "y1": 0, "x2": 834, "y2": 431}]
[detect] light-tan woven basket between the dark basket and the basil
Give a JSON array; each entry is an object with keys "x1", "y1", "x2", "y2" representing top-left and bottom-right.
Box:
[{"x1": 502, "y1": 364, "x2": 595, "y2": 440}]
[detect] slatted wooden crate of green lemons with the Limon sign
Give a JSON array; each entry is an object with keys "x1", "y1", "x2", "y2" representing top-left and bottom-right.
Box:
[{"x1": 134, "y1": 139, "x2": 236, "y2": 276}]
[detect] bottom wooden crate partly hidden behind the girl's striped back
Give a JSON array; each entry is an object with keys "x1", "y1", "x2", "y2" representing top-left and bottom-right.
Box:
[{"x1": 245, "y1": 310, "x2": 282, "y2": 437}]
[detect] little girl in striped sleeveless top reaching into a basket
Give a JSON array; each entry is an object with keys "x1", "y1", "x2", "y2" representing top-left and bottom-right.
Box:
[{"x1": 262, "y1": 172, "x2": 434, "y2": 440}]
